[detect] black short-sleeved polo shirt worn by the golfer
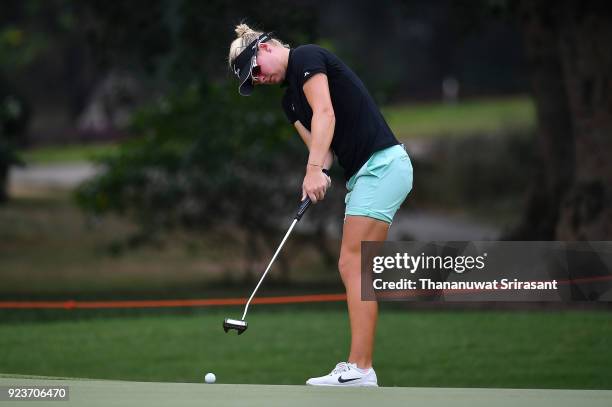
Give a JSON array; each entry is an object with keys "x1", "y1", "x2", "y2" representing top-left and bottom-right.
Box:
[{"x1": 283, "y1": 44, "x2": 399, "y2": 180}]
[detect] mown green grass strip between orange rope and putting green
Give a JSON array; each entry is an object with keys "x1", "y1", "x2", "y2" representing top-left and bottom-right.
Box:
[{"x1": 0, "y1": 304, "x2": 612, "y2": 389}]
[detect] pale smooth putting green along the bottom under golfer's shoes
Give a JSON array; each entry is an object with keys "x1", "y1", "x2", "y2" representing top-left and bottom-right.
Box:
[{"x1": 0, "y1": 378, "x2": 612, "y2": 407}]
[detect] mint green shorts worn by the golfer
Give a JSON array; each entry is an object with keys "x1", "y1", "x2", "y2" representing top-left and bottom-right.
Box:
[{"x1": 344, "y1": 145, "x2": 412, "y2": 223}]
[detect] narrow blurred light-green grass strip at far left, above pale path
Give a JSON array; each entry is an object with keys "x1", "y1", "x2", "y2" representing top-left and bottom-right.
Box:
[{"x1": 20, "y1": 143, "x2": 119, "y2": 164}]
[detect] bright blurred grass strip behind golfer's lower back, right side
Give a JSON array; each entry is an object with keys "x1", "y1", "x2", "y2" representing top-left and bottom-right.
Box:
[{"x1": 382, "y1": 96, "x2": 536, "y2": 140}]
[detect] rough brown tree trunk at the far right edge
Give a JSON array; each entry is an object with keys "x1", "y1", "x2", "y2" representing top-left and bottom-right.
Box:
[{"x1": 556, "y1": 0, "x2": 612, "y2": 240}]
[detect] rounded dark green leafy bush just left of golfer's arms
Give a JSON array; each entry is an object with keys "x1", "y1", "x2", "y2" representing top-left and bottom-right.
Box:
[{"x1": 77, "y1": 83, "x2": 305, "y2": 239}]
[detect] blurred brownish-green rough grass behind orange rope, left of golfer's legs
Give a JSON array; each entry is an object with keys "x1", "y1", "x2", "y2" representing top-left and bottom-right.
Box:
[{"x1": 0, "y1": 192, "x2": 337, "y2": 298}]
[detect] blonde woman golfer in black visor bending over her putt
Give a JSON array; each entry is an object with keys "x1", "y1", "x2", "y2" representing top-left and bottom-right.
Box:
[{"x1": 229, "y1": 24, "x2": 412, "y2": 386}]
